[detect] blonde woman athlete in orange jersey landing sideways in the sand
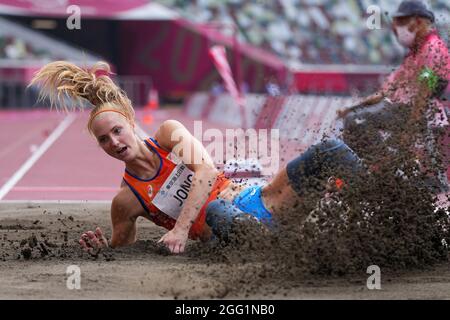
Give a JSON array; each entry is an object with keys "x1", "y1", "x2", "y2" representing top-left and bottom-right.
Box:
[{"x1": 30, "y1": 61, "x2": 359, "y2": 254}]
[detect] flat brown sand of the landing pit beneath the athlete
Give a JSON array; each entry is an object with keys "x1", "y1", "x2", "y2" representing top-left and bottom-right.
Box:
[{"x1": 0, "y1": 203, "x2": 450, "y2": 299}]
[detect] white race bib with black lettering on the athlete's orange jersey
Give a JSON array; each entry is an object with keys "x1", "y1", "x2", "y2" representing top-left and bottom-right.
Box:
[{"x1": 152, "y1": 163, "x2": 194, "y2": 220}]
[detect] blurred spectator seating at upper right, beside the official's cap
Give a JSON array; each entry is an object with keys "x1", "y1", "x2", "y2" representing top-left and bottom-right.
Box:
[{"x1": 158, "y1": 0, "x2": 450, "y2": 67}]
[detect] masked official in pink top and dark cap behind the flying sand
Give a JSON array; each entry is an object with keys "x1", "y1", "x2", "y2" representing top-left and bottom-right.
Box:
[{"x1": 339, "y1": 1, "x2": 450, "y2": 122}]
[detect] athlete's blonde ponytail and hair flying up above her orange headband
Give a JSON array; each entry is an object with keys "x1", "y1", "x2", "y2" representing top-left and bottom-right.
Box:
[{"x1": 29, "y1": 61, "x2": 135, "y2": 133}]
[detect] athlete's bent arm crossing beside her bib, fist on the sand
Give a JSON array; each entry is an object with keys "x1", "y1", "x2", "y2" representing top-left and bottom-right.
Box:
[{"x1": 155, "y1": 120, "x2": 218, "y2": 253}]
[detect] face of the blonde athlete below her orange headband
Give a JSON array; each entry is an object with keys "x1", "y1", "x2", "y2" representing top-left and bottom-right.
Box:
[{"x1": 91, "y1": 112, "x2": 139, "y2": 162}]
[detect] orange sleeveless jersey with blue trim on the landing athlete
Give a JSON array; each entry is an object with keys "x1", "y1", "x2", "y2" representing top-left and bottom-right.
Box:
[{"x1": 123, "y1": 138, "x2": 230, "y2": 239}]
